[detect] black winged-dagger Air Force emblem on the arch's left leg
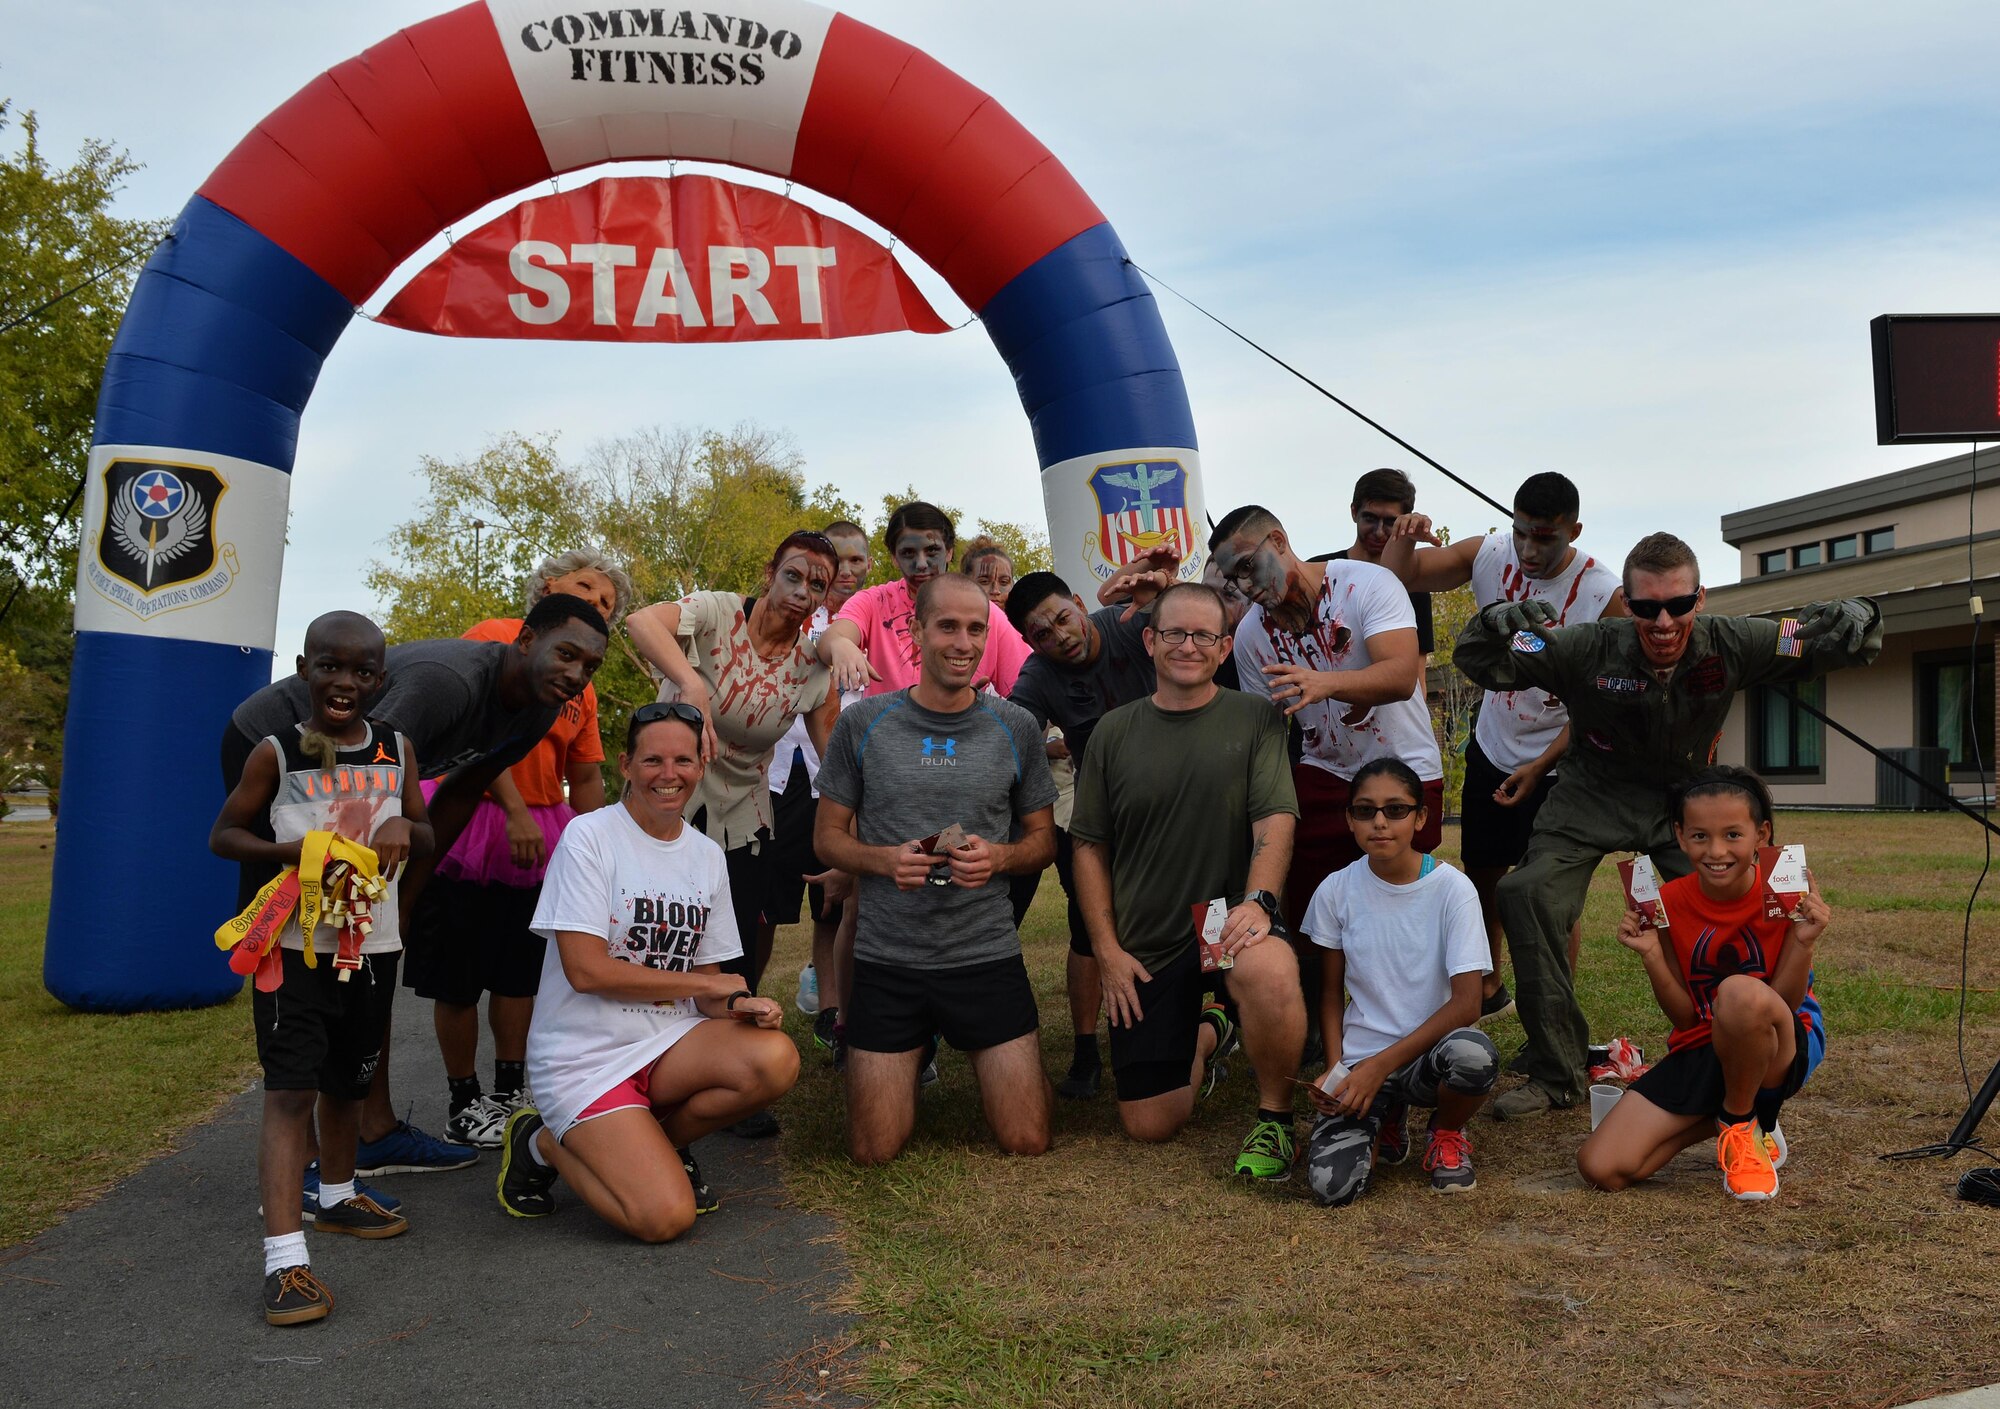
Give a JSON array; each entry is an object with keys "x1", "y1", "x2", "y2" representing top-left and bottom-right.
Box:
[{"x1": 86, "y1": 460, "x2": 238, "y2": 620}]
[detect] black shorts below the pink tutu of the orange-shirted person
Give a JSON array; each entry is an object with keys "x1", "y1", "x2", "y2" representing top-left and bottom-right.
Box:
[{"x1": 402, "y1": 875, "x2": 548, "y2": 1007}]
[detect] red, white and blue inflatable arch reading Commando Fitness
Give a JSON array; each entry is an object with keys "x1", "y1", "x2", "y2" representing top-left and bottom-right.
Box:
[{"x1": 44, "y1": 0, "x2": 1204, "y2": 1011}]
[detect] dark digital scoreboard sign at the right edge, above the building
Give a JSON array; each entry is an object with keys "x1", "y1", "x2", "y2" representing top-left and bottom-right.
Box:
[{"x1": 1868, "y1": 312, "x2": 2000, "y2": 444}]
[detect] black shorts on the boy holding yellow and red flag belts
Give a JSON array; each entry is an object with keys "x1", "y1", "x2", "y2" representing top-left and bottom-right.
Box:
[{"x1": 250, "y1": 945, "x2": 402, "y2": 1101}]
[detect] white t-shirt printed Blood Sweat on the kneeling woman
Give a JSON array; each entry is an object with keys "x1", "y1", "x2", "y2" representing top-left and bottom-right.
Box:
[{"x1": 528, "y1": 803, "x2": 744, "y2": 1139}]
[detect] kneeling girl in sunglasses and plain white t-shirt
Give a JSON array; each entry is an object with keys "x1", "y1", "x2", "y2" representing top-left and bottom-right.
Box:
[{"x1": 1300, "y1": 759, "x2": 1500, "y2": 1207}]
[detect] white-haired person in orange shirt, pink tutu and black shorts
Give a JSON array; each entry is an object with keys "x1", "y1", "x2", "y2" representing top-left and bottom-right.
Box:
[{"x1": 404, "y1": 548, "x2": 632, "y2": 1149}]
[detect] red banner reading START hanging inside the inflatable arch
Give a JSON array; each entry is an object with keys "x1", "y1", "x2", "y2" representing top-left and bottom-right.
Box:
[{"x1": 376, "y1": 176, "x2": 950, "y2": 342}]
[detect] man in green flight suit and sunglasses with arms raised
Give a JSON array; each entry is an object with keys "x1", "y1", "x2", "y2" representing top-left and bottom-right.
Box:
[{"x1": 1452, "y1": 532, "x2": 1882, "y2": 1121}]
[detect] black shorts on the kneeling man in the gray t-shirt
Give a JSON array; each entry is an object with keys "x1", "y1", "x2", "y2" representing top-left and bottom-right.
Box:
[{"x1": 840, "y1": 955, "x2": 1042, "y2": 1053}]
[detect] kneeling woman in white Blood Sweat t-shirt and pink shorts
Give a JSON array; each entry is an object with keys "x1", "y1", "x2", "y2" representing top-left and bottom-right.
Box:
[{"x1": 500, "y1": 702, "x2": 798, "y2": 1243}]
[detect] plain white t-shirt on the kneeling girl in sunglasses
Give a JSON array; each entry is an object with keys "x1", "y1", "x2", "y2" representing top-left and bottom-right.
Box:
[{"x1": 1300, "y1": 857, "x2": 1492, "y2": 1067}]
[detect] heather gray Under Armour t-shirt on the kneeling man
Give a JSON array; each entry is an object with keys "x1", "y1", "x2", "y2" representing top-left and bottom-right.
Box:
[{"x1": 820, "y1": 690, "x2": 1056, "y2": 969}]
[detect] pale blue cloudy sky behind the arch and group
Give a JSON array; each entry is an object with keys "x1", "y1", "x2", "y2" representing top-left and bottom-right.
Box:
[{"x1": 11, "y1": 0, "x2": 2000, "y2": 660}]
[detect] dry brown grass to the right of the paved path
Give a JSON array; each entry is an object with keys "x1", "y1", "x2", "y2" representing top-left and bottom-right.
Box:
[{"x1": 786, "y1": 815, "x2": 2000, "y2": 1409}]
